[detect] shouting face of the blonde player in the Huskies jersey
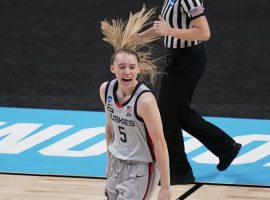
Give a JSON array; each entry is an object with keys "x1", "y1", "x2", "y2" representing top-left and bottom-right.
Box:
[{"x1": 111, "y1": 52, "x2": 140, "y2": 87}]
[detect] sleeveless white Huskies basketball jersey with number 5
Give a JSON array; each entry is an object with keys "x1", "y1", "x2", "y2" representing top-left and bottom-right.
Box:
[{"x1": 105, "y1": 79, "x2": 155, "y2": 162}]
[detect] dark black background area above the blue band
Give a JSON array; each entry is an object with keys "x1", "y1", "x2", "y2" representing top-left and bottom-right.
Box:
[{"x1": 0, "y1": 0, "x2": 270, "y2": 119}]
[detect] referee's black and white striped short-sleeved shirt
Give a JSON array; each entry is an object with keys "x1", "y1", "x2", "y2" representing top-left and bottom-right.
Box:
[{"x1": 161, "y1": 0, "x2": 204, "y2": 49}]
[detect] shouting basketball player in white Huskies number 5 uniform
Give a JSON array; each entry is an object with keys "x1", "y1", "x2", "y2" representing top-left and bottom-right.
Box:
[{"x1": 100, "y1": 8, "x2": 171, "y2": 200}]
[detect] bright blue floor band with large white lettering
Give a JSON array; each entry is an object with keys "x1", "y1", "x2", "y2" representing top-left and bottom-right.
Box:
[{"x1": 0, "y1": 107, "x2": 270, "y2": 186}]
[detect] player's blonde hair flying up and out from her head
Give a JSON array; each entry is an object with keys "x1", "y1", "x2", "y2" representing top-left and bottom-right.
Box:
[{"x1": 101, "y1": 6, "x2": 159, "y2": 84}]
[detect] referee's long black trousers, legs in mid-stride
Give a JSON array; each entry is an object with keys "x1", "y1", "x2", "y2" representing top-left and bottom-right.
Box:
[{"x1": 158, "y1": 44, "x2": 235, "y2": 177}]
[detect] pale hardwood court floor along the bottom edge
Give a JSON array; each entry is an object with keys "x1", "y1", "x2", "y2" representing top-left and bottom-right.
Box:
[{"x1": 0, "y1": 174, "x2": 270, "y2": 200}]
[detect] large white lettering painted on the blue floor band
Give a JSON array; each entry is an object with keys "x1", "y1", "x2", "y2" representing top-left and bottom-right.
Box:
[{"x1": 0, "y1": 122, "x2": 270, "y2": 167}]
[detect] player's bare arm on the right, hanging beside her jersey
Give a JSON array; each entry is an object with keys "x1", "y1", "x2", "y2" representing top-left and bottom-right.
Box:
[{"x1": 137, "y1": 92, "x2": 170, "y2": 195}]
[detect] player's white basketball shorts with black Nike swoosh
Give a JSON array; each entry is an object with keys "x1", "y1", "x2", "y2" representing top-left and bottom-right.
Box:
[{"x1": 105, "y1": 156, "x2": 160, "y2": 200}]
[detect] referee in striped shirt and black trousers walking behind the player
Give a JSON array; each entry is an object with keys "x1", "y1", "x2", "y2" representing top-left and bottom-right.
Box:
[{"x1": 135, "y1": 0, "x2": 241, "y2": 185}]
